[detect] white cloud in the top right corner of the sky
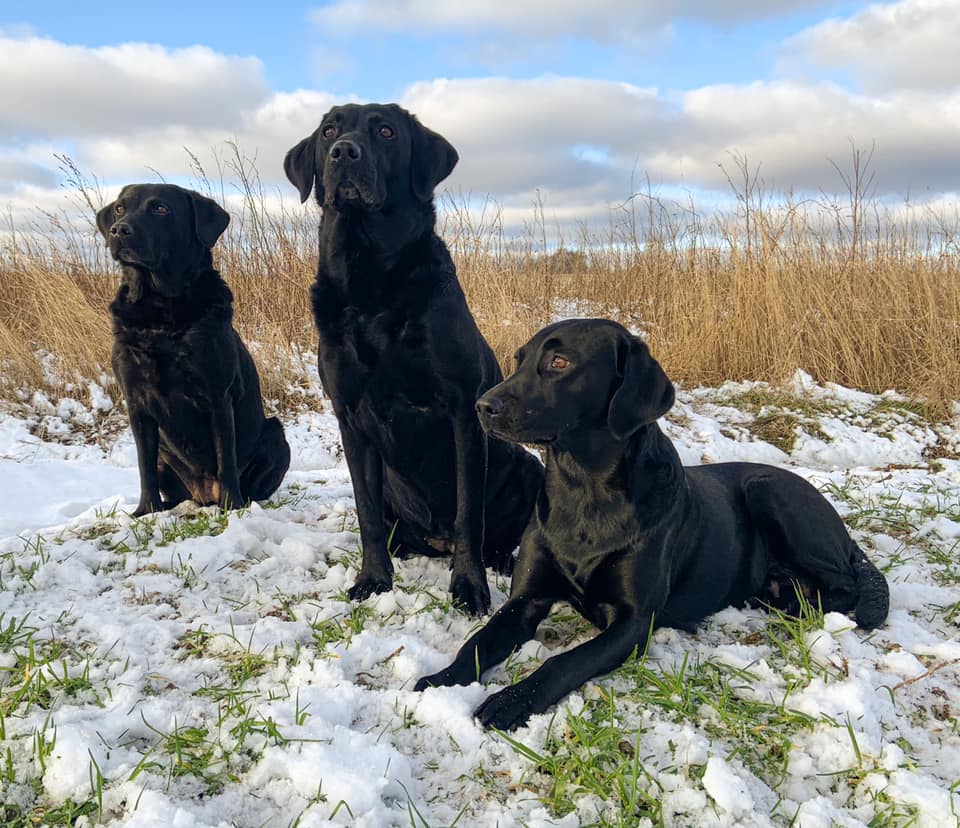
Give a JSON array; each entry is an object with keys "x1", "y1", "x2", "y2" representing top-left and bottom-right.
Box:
[{"x1": 780, "y1": 0, "x2": 960, "y2": 93}]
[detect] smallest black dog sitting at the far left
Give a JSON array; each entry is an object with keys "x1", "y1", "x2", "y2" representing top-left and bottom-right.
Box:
[{"x1": 97, "y1": 184, "x2": 290, "y2": 516}]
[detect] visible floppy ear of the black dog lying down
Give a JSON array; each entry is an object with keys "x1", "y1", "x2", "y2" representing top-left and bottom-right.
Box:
[{"x1": 607, "y1": 332, "x2": 676, "y2": 440}]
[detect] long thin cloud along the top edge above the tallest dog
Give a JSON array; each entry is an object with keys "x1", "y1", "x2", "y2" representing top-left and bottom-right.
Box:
[{"x1": 310, "y1": 0, "x2": 825, "y2": 41}]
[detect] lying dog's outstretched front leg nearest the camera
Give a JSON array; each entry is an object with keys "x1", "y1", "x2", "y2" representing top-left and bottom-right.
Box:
[{"x1": 476, "y1": 613, "x2": 652, "y2": 730}]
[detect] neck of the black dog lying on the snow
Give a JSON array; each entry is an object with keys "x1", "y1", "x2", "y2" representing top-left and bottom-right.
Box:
[{"x1": 546, "y1": 423, "x2": 683, "y2": 502}]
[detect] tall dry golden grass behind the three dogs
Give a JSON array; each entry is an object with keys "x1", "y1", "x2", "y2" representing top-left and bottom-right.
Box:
[{"x1": 0, "y1": 150, "x2": 960, "y2": 409}]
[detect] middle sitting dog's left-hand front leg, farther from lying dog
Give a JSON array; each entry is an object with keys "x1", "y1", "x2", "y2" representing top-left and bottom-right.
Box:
[{"x1": 340, "y1": 420, "x2": 393, "y2": 601}]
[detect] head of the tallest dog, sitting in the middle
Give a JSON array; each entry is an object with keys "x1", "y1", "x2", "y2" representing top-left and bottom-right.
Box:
[{"x1": 283, "y1": 104, "x2": 458, "y2": 212}]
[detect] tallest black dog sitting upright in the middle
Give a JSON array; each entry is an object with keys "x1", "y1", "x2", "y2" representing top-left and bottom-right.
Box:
[{"x1": 284, "y1": 104, "x2": 543, "y2": 613}]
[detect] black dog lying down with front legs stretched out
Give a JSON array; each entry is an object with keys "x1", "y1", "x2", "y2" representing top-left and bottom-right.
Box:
[{"x1": 416, "y1": 319, "x2": 888, "y2": 729}]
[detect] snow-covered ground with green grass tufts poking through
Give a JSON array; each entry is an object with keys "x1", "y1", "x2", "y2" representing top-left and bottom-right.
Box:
[{"x1": 0, "y1": 374, "x2": 960, "y2": 828}]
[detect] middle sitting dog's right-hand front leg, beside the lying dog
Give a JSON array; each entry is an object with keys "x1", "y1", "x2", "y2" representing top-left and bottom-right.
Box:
[{"x1": 450, "y1": 410, "x2": 490, "y2": 615}]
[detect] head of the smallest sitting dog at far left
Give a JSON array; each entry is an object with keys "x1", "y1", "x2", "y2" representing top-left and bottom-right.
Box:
[{"x1": 97, "y1": 184, "x2": 230, "y2": 297}]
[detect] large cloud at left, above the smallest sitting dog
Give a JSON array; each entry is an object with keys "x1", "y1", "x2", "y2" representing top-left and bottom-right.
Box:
[{"x1": 0, "y1": 35, "x2": 342, "y2": 203}]
